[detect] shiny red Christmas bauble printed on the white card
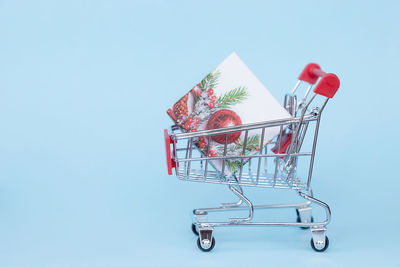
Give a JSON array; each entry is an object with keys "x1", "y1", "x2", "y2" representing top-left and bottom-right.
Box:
[{"x1": 207, "y1": 109, "x2": 242, "y2": 144}]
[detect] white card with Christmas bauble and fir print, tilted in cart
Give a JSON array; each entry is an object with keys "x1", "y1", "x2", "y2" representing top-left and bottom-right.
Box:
[{"x1": 167, "y1": 53, "x2": 290, "y2": 177}]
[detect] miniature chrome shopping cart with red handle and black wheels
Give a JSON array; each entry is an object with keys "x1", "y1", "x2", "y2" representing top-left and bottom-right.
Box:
[{"x1": 164, "y1": 63, "x2": 340, "y2": 252}]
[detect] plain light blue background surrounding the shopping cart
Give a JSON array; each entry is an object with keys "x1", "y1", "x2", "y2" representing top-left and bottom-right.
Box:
[{"x1": 0, "y1": 0, "x2": 400, "y2": 266}]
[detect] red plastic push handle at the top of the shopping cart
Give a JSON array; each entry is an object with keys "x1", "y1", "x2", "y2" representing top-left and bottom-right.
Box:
[{"x1": 299, "y1": 63, "x2": 340, "y2": 98}]
